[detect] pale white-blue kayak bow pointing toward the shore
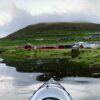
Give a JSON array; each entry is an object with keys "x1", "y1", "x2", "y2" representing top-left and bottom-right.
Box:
[{"x1": 30, "y1": 79, "x2": 72, "y2": 100}]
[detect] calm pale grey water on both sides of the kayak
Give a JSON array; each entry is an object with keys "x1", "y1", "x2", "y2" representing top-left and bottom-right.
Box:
[{"x1": 0, "y1": 58, "x2": 100, "y2": 100}]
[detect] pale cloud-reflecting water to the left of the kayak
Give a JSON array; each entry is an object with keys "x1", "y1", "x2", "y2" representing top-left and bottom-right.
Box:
[{"x1": 0, "y1": 64, "x2": 40, "y2": 100}]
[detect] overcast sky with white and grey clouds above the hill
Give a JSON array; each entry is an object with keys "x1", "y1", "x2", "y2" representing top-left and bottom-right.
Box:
[{"x1": 0, "y1": 0, "x2": 100, "y2": 37}]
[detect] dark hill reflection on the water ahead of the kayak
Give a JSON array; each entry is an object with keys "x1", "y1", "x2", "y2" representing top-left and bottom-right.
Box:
[{"x1": 2, "y1": 58, "x2": 99, "y2": 81}]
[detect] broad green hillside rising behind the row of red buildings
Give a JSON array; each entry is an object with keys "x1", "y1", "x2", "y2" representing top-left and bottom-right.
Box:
[{"x1": 0, "y1": 22, "x2": 100, "y2": 46}]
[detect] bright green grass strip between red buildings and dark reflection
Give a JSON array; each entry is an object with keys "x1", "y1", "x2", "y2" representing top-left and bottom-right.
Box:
[{"x1": 1, "y1": 48, "x2": 100, "y2": 64}]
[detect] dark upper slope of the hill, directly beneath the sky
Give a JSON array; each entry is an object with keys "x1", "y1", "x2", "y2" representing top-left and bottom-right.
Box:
[{"x1": 3, "y1": 22, "x2": 100, "y2": 39}]
